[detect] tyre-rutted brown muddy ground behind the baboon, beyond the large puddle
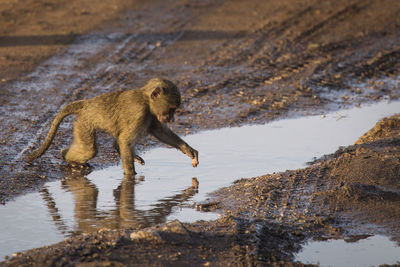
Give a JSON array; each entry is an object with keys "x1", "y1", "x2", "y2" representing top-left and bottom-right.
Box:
[{"x1": 0, "y1": 0, "x2": 400, "y2": 203}]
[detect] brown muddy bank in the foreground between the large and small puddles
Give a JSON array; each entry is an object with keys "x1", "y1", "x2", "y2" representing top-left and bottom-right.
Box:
[{"x1": 0, "y1": 115, "x2": 400, "y2": 266}]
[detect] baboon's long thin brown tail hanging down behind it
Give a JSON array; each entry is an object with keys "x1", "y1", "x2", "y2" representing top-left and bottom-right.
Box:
[{"x1": 26, "y1": 100, "x2": 83, "y2": 162}]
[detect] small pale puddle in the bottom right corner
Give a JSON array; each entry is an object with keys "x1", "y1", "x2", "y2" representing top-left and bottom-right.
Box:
[{"x1": 295, "y1": 235, "x2": 400, "y2": 267}]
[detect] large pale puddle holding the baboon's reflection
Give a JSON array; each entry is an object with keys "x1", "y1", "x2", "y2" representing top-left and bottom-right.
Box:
[{"x1": 0, "y1": 102, "x2": 400, "y2": 256}]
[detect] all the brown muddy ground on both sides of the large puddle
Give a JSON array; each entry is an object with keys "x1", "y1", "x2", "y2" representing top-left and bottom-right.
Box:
[{"x1": 0, "y1": 0, "x2": 400, "y2": 266}]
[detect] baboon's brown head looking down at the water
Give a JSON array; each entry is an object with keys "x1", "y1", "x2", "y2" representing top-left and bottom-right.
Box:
[{"x1": 145, "y1": 78, "x2": 181, "y2": 123}]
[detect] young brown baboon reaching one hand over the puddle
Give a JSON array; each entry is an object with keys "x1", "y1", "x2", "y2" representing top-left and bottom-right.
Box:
[{"x1": 27, "y1": 78, "x2": 199, "y2": 175}]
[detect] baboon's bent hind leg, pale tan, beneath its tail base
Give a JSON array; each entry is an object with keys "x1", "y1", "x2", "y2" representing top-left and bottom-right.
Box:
[{"x1": 62, "y1": 120, "x2": 97, "y2": 164}]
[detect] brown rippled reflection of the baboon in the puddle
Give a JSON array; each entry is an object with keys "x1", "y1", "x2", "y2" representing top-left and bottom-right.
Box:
[{"x1": 41, "y1": 172, "x2": 198, "y2": 233}]
